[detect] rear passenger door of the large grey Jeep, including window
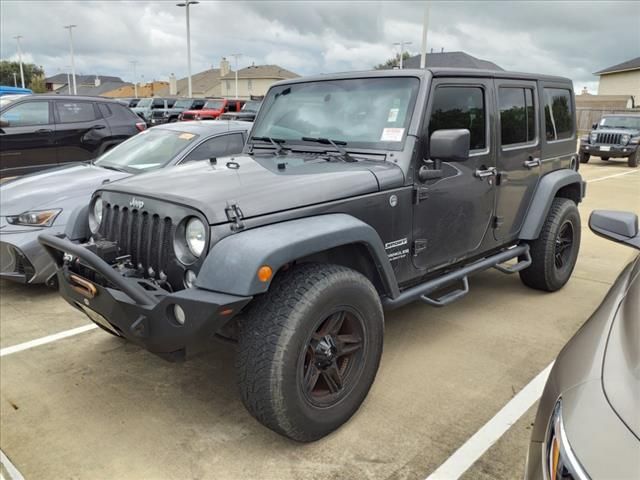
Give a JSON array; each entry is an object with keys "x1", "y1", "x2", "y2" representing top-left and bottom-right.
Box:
[{"x1": 493, "y1": 79, "x2": 541, "y2": 243}]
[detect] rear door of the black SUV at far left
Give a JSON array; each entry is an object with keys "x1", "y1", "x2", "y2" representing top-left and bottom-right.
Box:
[{"x1": 54, "y1": 100, "x2": 111, "y2": 163}]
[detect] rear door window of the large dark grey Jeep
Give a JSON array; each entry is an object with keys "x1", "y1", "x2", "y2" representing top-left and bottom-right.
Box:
[{"x1": 498, "y1": 87, "x2": 536, "y2": 146}]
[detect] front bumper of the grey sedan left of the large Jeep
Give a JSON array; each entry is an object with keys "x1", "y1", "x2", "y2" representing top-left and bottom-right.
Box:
[{"x1": 0, "y1": 224, "x2": 64, "y2": 284}]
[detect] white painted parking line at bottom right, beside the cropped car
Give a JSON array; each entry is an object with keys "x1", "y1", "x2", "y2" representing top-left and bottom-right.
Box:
[{"x1": 427, "y1": 362, "x2": 553, "y2": 480}]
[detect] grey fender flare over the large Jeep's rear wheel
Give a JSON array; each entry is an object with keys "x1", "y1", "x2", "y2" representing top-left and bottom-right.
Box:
[{"x1": 519, "y1": 169, "x2": 586, "y2": 240}]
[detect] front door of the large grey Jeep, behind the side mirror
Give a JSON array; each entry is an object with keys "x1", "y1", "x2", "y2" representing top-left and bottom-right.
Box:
[{"x1": 413, "y1": 78, "x2": 496, "y2": 271}]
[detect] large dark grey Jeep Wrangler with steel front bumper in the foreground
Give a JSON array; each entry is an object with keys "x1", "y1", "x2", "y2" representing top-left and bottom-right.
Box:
[{"x1": 40, "y1": 69, "x2": 585, "y2": 441}]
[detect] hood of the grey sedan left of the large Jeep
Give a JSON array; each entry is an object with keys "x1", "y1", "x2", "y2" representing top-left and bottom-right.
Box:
[{"x1": 0, "y1": 163, "x2": 131, "y2": 216}]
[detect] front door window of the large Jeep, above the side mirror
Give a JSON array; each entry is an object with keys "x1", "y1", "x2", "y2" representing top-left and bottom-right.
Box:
[{"x1": 429, "y1": 86, "x2": 487, "y2": 150}]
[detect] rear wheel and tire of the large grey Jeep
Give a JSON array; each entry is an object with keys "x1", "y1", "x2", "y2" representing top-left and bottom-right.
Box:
[{"x1": 520, "y1": 198, "x2": 580, "y2": 292}]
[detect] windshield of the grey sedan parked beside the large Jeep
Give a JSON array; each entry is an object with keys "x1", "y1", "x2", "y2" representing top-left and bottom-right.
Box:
[{"x1": 95, "y1": 128, "x2": 198, "y2": 172}]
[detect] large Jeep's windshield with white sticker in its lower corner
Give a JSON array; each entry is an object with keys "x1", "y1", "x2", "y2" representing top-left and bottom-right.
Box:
[{"x1": 252, "y1": 77, "x2": 419, "y2": 149}]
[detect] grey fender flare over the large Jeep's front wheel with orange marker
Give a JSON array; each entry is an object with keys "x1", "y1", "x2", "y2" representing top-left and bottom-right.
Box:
[{"x1": 196, "y1": 213, "x2": 399, "y2": 297}]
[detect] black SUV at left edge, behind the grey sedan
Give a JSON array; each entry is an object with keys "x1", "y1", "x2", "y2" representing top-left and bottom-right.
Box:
[{"x1": 0, "y1": 95, "x2": 146, "y2": 177}]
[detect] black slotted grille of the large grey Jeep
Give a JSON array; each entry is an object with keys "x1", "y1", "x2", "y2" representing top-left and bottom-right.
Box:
[{"x1": 100, "y1": 203, "x2": 172, "y2": 278}]
